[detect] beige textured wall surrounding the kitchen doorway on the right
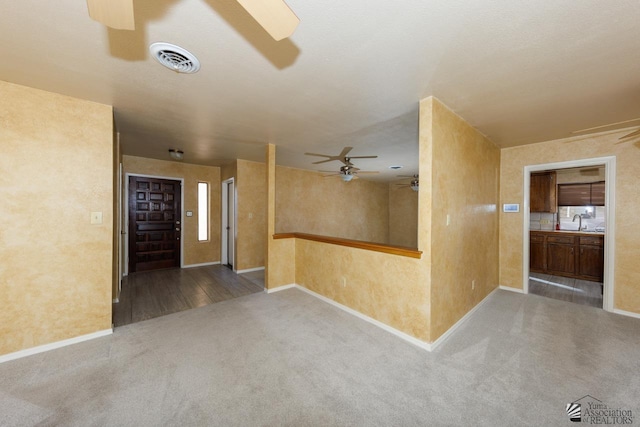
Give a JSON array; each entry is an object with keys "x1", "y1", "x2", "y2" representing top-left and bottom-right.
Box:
[{"x1": 500, "y1": 131, "x2": 640, "y2": 313}]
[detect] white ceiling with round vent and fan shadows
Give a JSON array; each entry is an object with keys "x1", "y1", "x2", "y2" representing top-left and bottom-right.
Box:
[{"x1": 0, "y1": 0, "x2": 640, "y2": 179}]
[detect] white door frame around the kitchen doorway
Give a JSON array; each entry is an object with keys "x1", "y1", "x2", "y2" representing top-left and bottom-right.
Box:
[{"x1": 522, "y1": 156, "x2": 616, "y2": 311}]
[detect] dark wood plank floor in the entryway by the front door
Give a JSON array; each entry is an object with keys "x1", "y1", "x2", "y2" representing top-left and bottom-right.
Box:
[{"x1": 113, "y1": 265, "x2": 264, "y2": 327}]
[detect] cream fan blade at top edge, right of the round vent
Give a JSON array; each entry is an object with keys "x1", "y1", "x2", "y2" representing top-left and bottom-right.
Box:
[{"x1": 238, "y1": 0, "x2": 300, "y2": 41}]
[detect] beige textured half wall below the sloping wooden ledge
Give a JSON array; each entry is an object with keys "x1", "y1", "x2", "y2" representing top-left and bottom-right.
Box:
[{"x1": 290, "y1": 239, "x2": 429, "y2": 342}]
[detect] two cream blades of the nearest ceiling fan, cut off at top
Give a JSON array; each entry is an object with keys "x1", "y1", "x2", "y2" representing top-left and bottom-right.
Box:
[{"x1": 87, "y1": 0, "x2": 300, "y2": 41}]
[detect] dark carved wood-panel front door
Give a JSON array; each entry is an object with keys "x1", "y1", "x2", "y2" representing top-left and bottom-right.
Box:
[{"x1": 129, "y1": 176, "x2": 182, "y2": 273}]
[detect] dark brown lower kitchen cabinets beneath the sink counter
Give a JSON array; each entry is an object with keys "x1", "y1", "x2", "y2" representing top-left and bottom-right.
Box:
[{"x1": 529, "y1": 231, "x2": 604, "y2": 282}]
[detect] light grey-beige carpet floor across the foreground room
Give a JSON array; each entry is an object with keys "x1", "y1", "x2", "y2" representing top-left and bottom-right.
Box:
[{"x1": 0, "y1": 289, "x2": 640, "y2": 426}]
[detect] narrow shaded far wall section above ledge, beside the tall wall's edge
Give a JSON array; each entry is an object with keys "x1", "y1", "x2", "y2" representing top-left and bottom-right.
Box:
[{"x1": 388, "y1": 183, "x2": 419, "y2": 248}]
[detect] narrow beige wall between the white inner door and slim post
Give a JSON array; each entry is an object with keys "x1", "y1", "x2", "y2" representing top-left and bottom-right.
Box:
[{"x1": 236, "y1": 160, "x2": 267, "y2": 270}]
